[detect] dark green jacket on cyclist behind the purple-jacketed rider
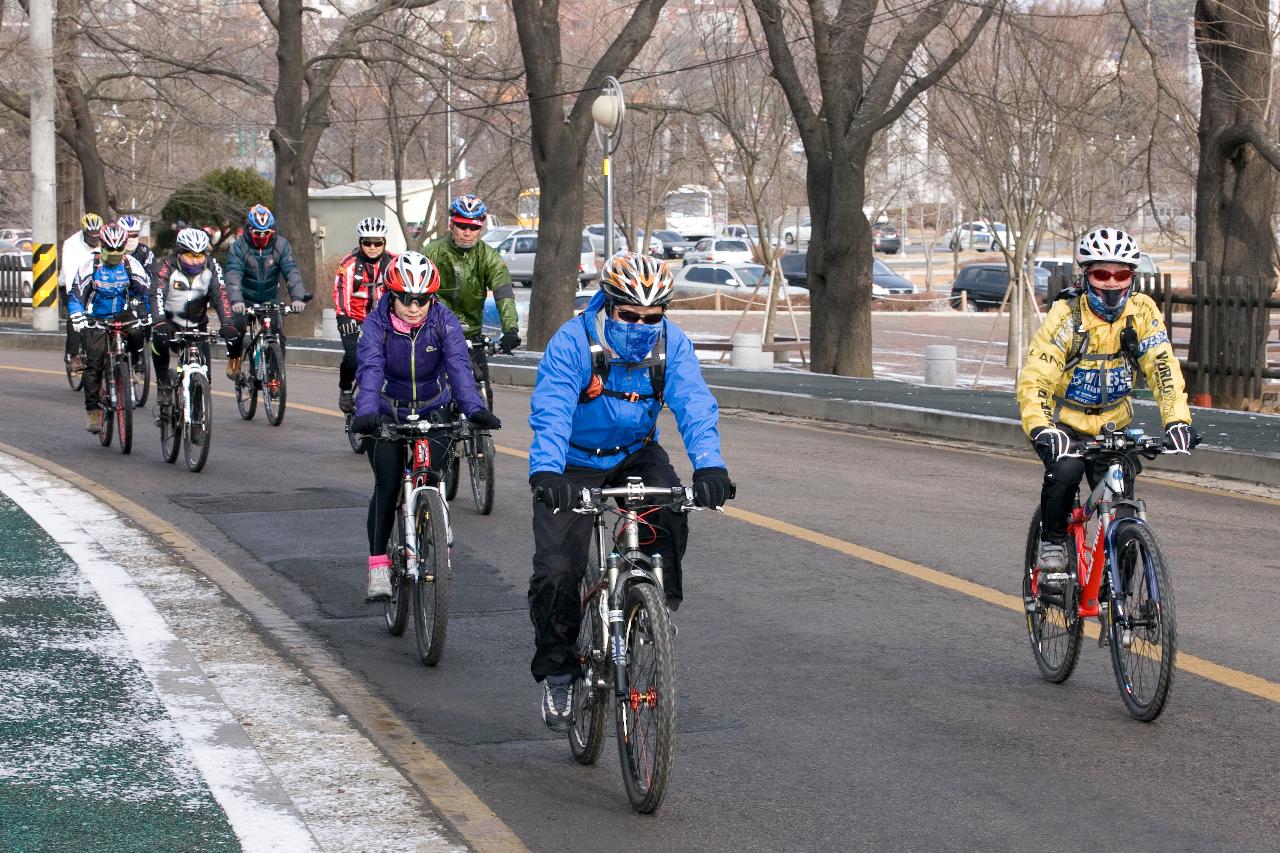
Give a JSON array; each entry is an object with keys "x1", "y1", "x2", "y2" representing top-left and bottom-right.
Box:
[{"x1": 422, "y1": 234, "x2": 520, "y2": 338}]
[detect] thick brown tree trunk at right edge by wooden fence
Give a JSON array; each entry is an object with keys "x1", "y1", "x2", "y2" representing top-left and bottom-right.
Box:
[{"x1": 1188, "y1": 0, "x2": 1275, "y2": 407}]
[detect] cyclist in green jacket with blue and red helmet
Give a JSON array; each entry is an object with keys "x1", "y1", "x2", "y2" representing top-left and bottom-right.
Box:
[{"x1": 422, "y1": 193, "x2": 520, "y2": 397}]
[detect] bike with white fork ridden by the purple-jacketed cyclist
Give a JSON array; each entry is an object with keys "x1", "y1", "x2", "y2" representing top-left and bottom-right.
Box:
[{"x1": 378, "y1": 415, "x2": 454, "y2": 666}]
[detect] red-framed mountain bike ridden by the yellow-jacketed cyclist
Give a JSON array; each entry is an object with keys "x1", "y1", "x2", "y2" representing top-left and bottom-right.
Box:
[{"x1": 1023, "y1": 424, "x2": 1198, "y2": 722}]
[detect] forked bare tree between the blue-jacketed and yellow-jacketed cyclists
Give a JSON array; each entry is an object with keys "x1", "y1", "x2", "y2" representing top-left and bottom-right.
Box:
[{"x1": 754, "y1": 0, "x2": 996, "y2": 377}]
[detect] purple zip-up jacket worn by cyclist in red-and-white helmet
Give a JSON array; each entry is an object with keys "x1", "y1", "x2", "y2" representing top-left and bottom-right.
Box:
[{"x1": 356, "y1": 293, "x2": 485, "y2": 420}]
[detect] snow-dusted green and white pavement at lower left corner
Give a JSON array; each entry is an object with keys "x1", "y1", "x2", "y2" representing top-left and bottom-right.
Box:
[{"x1": 0, "y1": 453, "x2": 466, "y2": 853}]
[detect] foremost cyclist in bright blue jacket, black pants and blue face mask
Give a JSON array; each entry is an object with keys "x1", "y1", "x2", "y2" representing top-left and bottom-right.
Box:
[{"x1": 529, "y1": 252, "x2": 732, "y2": 731}]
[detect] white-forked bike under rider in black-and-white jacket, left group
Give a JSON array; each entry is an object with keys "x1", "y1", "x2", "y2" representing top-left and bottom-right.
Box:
[{"x1": 156, "y1": 329, "x2": 218, "y2": 473}]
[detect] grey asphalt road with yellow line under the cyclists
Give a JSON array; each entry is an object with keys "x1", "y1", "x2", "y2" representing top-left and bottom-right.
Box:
[{"x1": 0, "y1": 350, "x2": 1280, "y2": 850}]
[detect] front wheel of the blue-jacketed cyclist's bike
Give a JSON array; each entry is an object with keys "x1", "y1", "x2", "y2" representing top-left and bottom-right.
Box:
[{"x1": 617, "y1": 583, "x2": 676, "y2": 815}]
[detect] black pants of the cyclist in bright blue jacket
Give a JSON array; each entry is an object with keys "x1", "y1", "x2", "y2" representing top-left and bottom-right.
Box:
[{"x1": 529, "y1": 444, "x2": 689, "y2": 681}]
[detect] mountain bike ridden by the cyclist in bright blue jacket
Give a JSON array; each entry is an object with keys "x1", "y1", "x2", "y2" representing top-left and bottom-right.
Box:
[{"x1": 568, "y1": 476, "x2": 732, "y2": 813}]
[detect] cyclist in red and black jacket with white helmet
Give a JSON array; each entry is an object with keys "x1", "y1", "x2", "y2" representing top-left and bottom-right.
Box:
[{"x1": 333, "y1": 216, "x2": 396, "y2": 412}]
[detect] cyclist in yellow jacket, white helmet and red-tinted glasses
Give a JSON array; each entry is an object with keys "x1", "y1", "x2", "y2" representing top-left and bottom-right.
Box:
[{"x1": 1018, "y1": 228, "x2": 1194, "y2": 583}]
